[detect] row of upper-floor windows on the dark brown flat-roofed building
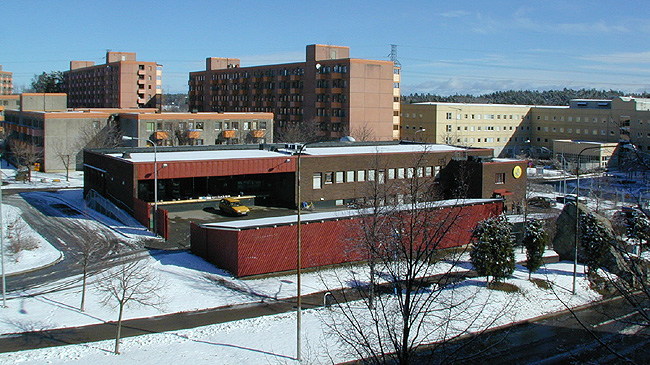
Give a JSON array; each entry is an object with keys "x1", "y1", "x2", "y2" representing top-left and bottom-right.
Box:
[{"x1": 312, "y1": 166, "x2": 440, "y2": 189}]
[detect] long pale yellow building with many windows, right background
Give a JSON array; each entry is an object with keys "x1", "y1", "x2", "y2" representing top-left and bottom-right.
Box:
[{"x1": 401, "y1": 97, "x2": 650, "y2": 156}]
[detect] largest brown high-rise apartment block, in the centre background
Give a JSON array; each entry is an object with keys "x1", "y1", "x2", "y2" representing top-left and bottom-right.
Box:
[{"x1": 189, "y1": 45, "x2": 400, "y2": 140}]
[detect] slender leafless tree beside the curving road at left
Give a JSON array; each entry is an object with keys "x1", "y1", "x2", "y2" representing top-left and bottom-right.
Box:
[{"x1": 73, "y1": 230, "x2": 118, "y2": 312}]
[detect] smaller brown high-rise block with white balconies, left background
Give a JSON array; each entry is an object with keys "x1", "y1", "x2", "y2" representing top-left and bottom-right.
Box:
[{"x1": 64, "y1": 52, "x2": 162, "y2": 108}]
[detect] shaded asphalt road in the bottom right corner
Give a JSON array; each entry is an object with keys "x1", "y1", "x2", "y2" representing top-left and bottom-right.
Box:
[{"x1": 416, "y1": 298, "x2": 650, "y2": 364}]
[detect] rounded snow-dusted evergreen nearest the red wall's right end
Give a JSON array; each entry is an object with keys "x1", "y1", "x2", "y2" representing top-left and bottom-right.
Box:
[{"x1": 470, "y1": 215, "x2": 515, "y2": 283}]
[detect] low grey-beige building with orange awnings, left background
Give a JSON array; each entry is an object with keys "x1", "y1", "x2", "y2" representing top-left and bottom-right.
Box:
[{"x1": 0, "y1": 93, "x2": 273, "y2": 172}]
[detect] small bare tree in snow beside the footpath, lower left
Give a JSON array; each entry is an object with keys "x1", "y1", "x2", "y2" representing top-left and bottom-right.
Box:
[{"x1": 97, "y1": 258, "x2": 164, "y2": 354}]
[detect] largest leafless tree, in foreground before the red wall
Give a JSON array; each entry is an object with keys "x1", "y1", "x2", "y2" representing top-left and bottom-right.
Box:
[{"x1": 324, "y1": 147, "x2": 503, "y2": 364}]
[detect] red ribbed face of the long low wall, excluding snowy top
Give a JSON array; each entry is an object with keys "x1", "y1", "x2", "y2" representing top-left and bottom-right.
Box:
[{"x1": 191, "y1": 202, "x2": 503, "y2": 277}]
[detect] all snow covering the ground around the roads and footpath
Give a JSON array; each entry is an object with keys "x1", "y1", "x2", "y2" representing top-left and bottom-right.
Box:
[{"x1": 0, "y1": 161, "x2": 599, "y2": 364}]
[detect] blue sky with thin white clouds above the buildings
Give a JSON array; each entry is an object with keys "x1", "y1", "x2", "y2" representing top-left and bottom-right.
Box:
[{"x1": 0, "y1": 0, "x2": 650, "y2": 95}]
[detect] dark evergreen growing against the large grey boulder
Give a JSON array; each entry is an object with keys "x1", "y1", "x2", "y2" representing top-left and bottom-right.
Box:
[{"x1": 580, "y1": 213, "x2": 615, "y2": 272}]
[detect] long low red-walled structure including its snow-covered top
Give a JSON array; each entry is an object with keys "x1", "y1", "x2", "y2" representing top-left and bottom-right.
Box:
[{"x1": 191, "y1": 199, "x2": 503, "y2": 277}]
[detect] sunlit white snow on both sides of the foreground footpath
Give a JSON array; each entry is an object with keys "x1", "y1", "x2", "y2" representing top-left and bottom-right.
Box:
[{"x1": 0, "y1": 262, "x2": 599, "y2": 364}]
